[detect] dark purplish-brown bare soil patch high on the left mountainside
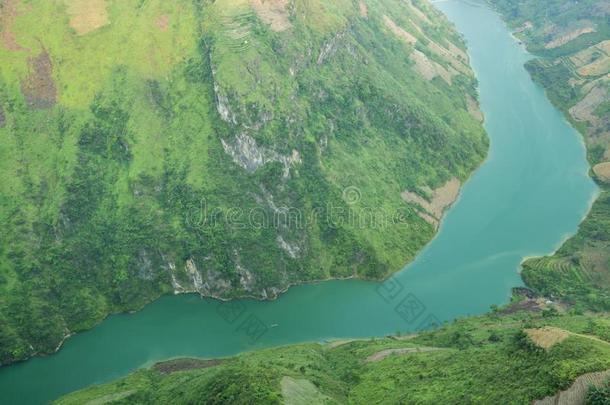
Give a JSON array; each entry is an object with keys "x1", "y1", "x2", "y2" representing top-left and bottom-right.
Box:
[{"x1": 21, "y1": 50, "x2": 57, "y2": 109}]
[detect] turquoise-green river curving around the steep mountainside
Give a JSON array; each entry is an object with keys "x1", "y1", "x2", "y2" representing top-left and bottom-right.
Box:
[{"x1": 0, "y1": 0, "x2": 596, "y2": 404}]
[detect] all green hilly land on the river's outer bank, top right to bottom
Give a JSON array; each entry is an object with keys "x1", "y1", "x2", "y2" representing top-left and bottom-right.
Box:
[{"x1": 57, "y1": 0, "x2": 610, "y2": 404}]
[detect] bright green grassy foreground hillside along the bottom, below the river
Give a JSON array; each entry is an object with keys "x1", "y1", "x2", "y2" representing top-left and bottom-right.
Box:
[{"x1": 57, "y1": 313, "x2": 610, "y2": 404}]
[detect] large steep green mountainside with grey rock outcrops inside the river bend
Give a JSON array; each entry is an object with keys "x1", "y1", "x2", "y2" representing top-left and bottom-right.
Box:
[{"x1": 0, "y1": 0, "x2": 487, "y2": 364}]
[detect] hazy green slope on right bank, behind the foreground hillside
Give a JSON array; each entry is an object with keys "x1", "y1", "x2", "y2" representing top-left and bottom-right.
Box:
[{"x1": 490, "y1": 0, "x2": 610, "y2": 311}]
